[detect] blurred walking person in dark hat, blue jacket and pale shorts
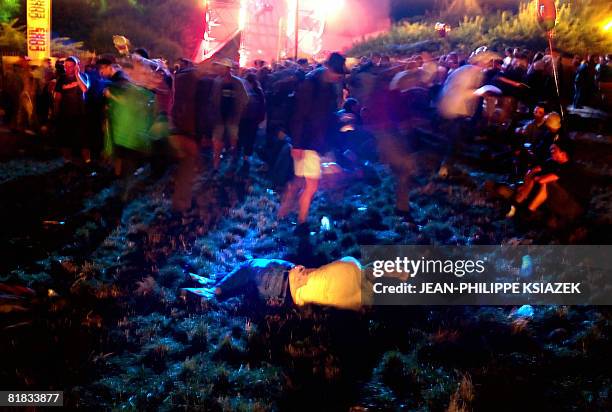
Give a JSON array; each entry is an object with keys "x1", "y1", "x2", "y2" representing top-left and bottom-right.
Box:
[{"x1": 279, "y1": 53, "x2": 347, "y2": 229}]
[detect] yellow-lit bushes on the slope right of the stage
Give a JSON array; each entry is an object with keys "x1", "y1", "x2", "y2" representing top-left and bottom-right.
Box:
[{"x1": 348, "y1": 0, "x2": 612, "y2": 56}]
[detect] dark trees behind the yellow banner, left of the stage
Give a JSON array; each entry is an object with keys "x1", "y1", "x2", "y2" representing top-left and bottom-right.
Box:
[{"x1": 0, "y1": 0, "x2": 204, "y2": 60}]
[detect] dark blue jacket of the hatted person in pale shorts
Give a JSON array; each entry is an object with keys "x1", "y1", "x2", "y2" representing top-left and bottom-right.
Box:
[{"x1": 290, "y1": 68, "x2": 340, "y2": 153}]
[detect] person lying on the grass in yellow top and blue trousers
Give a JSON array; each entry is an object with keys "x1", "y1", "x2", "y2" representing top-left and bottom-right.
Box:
[{"x1": 184, "y1": 257, "x2": 365, "y2": 310}]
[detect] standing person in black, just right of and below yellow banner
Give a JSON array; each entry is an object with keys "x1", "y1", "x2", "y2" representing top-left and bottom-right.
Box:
[{"x1": 54, "y1": 56, "x2": 91, "y2": 163}]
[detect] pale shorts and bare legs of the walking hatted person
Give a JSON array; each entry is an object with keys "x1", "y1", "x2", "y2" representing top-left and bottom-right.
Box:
[{"x1": 278, "y1": 149, "x2": 321, "y2": 224}]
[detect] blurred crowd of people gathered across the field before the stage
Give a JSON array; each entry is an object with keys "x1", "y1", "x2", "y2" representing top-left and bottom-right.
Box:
[{"x1": 2, "y1": 47, "x2": 612, "y2": 230}]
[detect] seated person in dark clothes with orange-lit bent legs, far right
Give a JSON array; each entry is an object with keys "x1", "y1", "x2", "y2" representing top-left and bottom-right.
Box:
[{"x1": 509, "y1": 140, "x2": 588, "y2": 223}]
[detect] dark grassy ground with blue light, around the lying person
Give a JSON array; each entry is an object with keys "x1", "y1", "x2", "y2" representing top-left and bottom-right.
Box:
[{"x1": 0, "y1": 126, "x2": 612, "y2": 411}]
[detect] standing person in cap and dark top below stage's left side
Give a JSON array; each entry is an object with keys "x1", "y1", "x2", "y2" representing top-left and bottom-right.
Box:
[{"x1": 211, "y1": 57, "x2": 249, "y2": 170}]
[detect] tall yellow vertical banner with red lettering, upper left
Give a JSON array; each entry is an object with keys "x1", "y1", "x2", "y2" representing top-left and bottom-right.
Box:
[{"x1": 26, "y1": 0, "x2": 51, "y2": 60}]
